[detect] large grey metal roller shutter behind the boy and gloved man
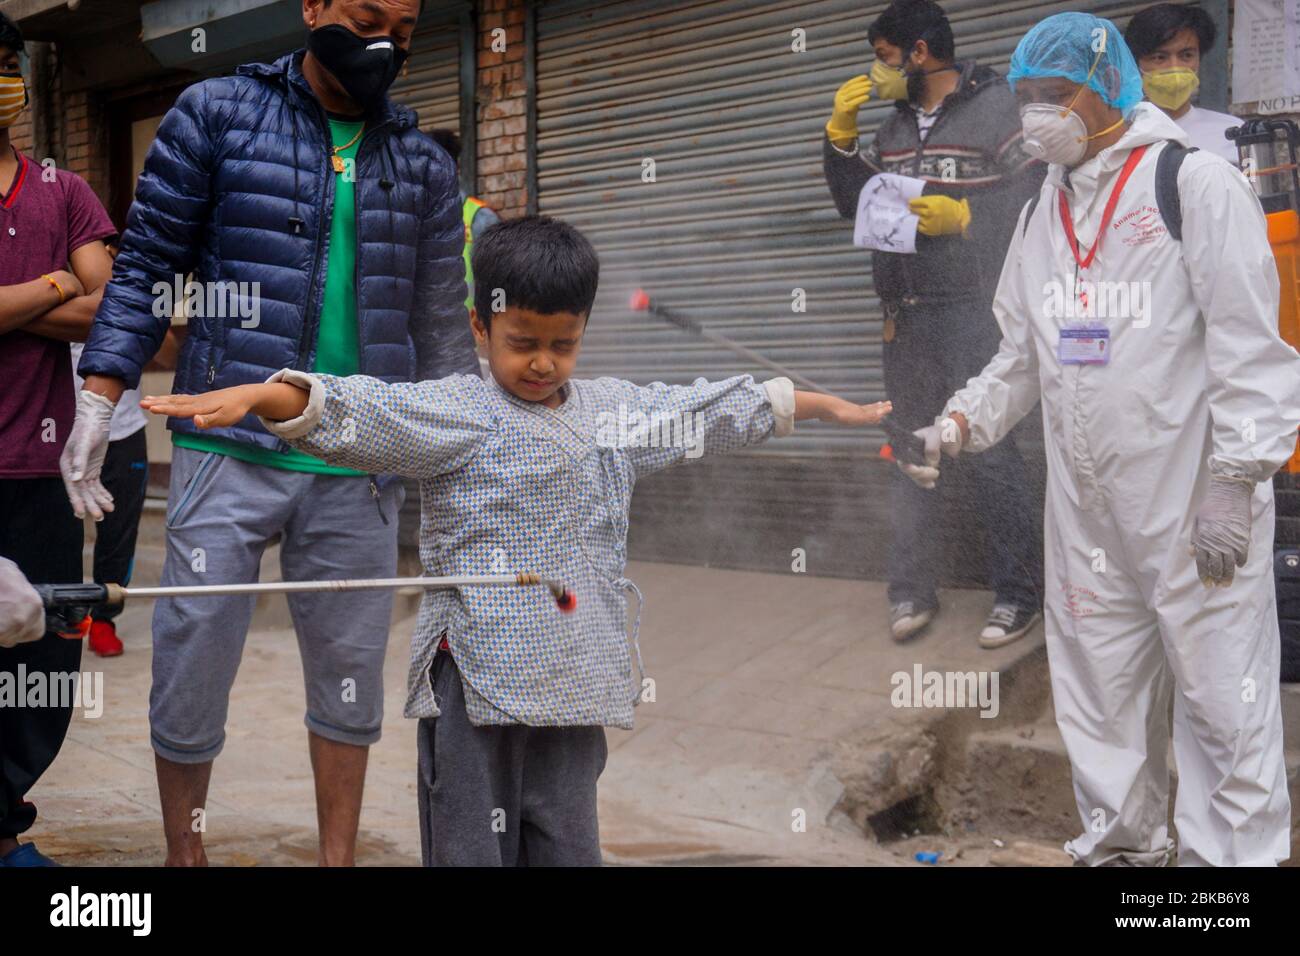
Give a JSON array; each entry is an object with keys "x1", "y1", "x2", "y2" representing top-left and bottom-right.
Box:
[{"x1": 537, "y1": 0, "x2": 1201, "y2": 580}]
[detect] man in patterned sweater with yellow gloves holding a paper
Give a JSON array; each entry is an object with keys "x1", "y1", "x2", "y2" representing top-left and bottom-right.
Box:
[{"x1": 824, "y1": 0, "x2": 1045, "y2": 646}]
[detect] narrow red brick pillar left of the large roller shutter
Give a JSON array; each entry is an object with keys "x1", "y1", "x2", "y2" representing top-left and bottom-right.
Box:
[{"x1": 475, "y1": 0, "x2": 528, "y2": 219}]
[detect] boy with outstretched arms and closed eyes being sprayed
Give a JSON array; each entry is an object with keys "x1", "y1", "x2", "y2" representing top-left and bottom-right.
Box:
[{"x1": 142, "y1": 217, "x2": 889, "y2": 866}]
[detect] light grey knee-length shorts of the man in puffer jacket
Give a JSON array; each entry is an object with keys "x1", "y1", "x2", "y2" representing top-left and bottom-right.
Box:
[{"x1": 150, "y1": 447, "x2": 403, "y2": 763}]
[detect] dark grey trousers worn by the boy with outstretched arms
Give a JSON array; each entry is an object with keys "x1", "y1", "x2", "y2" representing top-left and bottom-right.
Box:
[{"x1": 419, "y1": 650, "x2": 607, "y2": 866}]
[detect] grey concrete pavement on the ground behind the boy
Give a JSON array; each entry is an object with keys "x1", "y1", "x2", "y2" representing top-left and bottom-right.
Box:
[{"x1": 20, "y1": 522, "x2": 1060, "y2": 865}]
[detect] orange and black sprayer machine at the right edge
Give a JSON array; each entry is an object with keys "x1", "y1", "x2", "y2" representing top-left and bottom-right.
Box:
[{"x1": 1226, "y1": 120, "x2": 1300, "y2": 475}]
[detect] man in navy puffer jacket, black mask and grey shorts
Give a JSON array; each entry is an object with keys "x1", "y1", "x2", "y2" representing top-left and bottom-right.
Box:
[{"x1": 61, "y1": 0, "x2": 478, "y2": 865}]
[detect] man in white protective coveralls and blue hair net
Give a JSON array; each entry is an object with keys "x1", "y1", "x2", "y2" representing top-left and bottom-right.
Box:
[{"x1": 900, "y1": 13, "x2": 1300, "y2": 866}]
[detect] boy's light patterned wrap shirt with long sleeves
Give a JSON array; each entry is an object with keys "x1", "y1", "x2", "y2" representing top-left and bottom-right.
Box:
[{"x1": 264, "y1": 369, "x2": 794, "y2": 728}]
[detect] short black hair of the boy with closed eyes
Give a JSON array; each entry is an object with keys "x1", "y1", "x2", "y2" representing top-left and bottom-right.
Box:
[{"x1": 471, "y1": 216, "x2": 601, "y2": 329}]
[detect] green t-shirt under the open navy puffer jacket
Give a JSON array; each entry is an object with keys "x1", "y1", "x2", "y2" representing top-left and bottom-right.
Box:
[{"x1": 172, "y1": 117, "x2": 364, "y2": 475}]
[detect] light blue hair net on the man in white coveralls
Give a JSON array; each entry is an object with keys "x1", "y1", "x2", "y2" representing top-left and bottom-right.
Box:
[{"x1": 1006, "y1": 13, "x2": 1143, "y2": 114}]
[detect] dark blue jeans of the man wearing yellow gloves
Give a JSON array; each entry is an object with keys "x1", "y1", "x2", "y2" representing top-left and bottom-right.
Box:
[{"x1": 884, "y1": 299, "x2": 1043, "y2": 607}]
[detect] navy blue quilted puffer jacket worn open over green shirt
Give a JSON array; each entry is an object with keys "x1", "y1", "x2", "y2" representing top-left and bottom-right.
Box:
[{"x1": 78, "y1": 51, "x2": 478, "y2": 447}]
